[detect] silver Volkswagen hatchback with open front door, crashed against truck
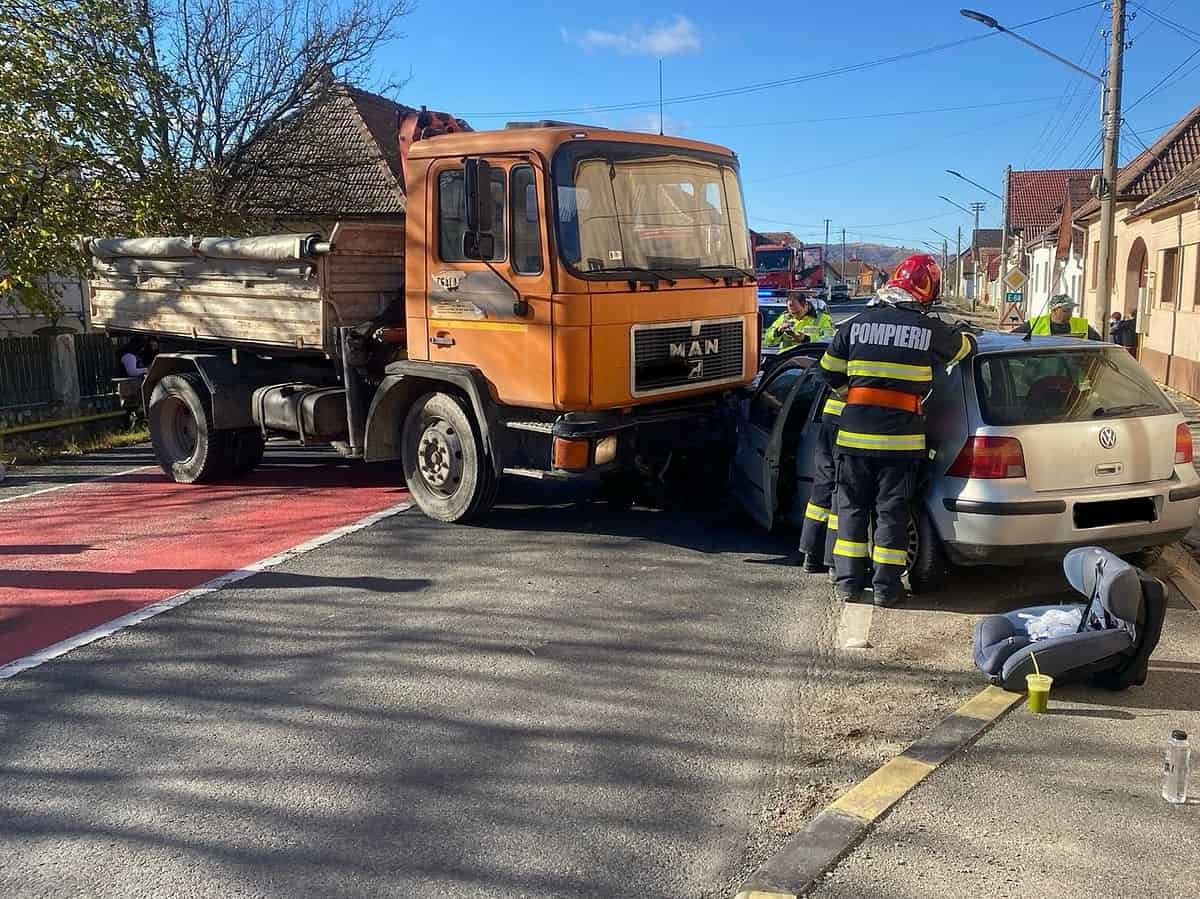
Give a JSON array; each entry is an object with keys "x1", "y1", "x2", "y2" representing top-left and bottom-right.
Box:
[{"x1": 732, "y1": 332, "x2": 1200, "y2": 593}]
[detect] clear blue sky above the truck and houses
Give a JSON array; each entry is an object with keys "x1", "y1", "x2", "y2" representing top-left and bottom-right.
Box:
[{"x1": 378, "y1": 0, "x2": 1200, "y2": 252}]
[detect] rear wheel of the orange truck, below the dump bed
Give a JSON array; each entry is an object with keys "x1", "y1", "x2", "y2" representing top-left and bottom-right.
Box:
[{"x1": 146, "y1": 374, "x2": 235, "y2": 484}]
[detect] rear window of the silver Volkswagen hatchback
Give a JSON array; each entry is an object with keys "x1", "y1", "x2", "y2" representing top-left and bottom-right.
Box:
[{"x1": 974, "y1": 346, "x2": 1175, "y2": 425}]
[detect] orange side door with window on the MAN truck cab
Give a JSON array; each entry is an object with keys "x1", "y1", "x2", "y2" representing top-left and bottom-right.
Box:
[{"x1": 425, "y1": 158, "x2": 553, "y2": 408}]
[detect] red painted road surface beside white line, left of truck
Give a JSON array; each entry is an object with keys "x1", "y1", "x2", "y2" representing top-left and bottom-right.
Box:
[{"x1": 0, "y1": 465, "x2": 408, "y2": 665}]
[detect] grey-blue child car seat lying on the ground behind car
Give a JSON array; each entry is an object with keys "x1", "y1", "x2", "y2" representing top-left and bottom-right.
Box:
[{"x1": 974, "y1": 546, "x2": 1166, "y2": 691}]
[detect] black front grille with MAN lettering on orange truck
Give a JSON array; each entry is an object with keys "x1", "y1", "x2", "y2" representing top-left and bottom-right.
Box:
[{"x1": 634, "y1": 318, "x2": 744, "y2": 396}]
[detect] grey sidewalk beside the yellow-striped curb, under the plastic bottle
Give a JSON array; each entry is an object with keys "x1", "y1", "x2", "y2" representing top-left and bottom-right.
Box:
[{"x1": 811, "y1": 594, "x2": 1200, "y2": 899}]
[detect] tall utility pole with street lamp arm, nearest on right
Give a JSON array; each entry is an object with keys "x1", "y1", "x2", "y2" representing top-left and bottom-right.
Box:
[{"x1": 959, "y1": 0, "x2": 1126, "y2": 331}]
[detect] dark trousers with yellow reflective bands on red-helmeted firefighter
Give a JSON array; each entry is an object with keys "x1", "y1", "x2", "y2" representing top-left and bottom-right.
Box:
[{"x1": 833, "y1": 453, "x2": 919, "y2": 599}]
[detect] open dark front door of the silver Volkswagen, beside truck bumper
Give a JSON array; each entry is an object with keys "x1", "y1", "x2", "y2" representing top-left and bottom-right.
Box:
[{"x1": 730, "y1": 355, "x2": 823, "y2": 531}]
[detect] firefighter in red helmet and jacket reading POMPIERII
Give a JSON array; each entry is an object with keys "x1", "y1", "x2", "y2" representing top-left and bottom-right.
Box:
[{"x1": 821, "y1": 253, "x2": 976, "y2": 606}]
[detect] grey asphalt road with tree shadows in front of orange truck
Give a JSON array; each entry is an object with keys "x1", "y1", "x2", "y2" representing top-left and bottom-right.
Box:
[{"x1": 0, "y1": 466, "x2": 836, "y2": 899}]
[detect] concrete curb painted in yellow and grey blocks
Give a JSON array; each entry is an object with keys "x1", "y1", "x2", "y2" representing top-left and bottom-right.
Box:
[{"x1": 736, "y1": 687, "x2": 1021, "y2": 899}]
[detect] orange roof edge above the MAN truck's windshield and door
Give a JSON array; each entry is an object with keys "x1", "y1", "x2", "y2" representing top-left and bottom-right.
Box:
[{"x1": 409, "y1": 122, "x2": 737, "y2": 160}]
